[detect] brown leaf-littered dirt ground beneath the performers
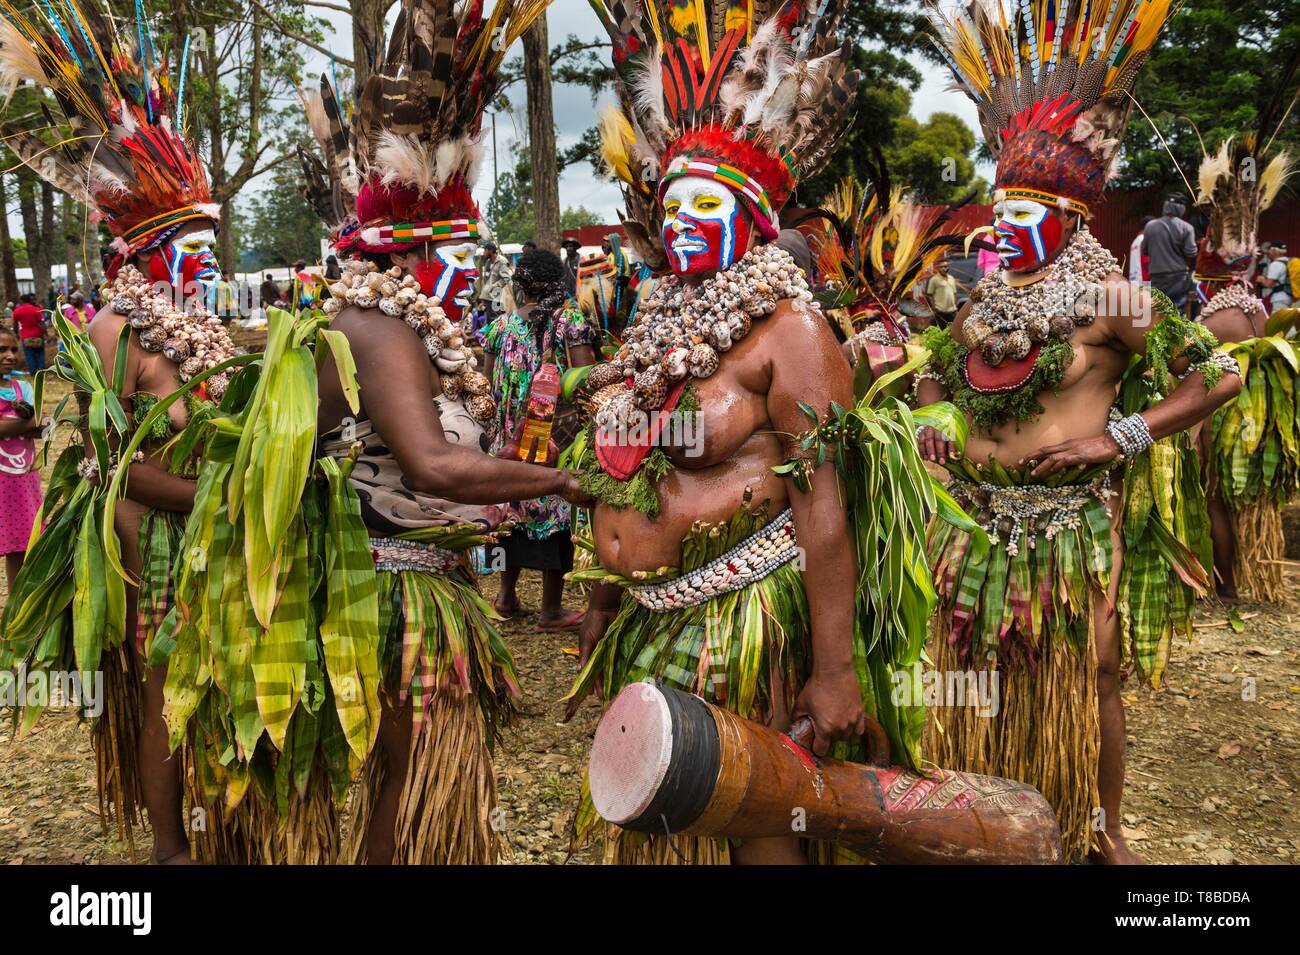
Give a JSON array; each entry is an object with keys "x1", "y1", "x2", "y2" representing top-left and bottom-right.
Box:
[{"x1": 0, "y1": 371, "x2": 1300, "y2": 864}]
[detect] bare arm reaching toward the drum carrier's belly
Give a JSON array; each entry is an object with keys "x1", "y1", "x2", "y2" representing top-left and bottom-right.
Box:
[{"x1": 338, "y1": 310, "x2": 585, "y2": 504}]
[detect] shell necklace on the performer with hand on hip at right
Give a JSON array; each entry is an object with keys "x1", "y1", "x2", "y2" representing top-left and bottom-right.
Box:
[{"x1": 962, "y1": 226, "x2": 1119, "y2": 368}]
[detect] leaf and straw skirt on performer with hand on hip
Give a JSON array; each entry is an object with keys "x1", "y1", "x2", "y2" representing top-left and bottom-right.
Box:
[{"x1": 924, "y1": 465, "x2": 1113, "y2": 860}]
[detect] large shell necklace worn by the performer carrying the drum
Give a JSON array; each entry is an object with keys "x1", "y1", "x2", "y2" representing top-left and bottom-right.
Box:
[{"x1": 586, "y1": 244, "x2": 813, "y2": 427}]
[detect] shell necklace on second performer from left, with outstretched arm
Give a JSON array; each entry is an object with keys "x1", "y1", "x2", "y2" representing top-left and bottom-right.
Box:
[{"x1": 321, "y1": 260, "x2": 497, "y2": 429}]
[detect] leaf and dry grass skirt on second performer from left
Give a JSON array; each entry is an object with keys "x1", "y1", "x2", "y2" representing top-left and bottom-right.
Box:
[{"x1": 343, "y1": 570, "x2": 519, "y2": 865}]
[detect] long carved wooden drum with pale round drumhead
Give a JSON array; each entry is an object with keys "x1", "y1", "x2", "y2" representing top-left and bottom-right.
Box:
[{"x1": 590, "y1": 683, "x2": 1062, "y2": 864}]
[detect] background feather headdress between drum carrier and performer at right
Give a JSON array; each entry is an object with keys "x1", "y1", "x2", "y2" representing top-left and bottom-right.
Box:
[{"x1": 813, "y1": 178, "x2": 965, "y2": 330}]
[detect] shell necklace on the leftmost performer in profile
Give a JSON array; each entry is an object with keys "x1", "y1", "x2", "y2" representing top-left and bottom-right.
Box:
[{"x1": 108, "y1": 265, "x2": 238, "y2": 401}]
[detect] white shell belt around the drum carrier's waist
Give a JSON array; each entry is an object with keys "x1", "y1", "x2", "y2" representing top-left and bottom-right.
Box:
[{"x1": 628, "y1": 508, "x2": 800, "y2": 613}]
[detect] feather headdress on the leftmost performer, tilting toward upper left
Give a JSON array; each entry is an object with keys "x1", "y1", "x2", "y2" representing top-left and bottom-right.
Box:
[{"x1": 0, "y1": 0, "x2": 220, "y2": 273}]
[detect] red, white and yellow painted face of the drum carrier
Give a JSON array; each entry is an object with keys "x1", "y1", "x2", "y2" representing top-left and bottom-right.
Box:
[{"x1": 662, "y1": 175, "x2": 753, "y2": 275}]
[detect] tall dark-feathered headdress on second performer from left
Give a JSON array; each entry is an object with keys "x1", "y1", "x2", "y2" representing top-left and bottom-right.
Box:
[{"x1": 352, "y1": 0, "x2": 550, "y2": 252}]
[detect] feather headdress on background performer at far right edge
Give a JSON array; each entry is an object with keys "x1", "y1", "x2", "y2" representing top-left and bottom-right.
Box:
[{"x1": 1196, "y1": 56, "x2": 1300, "y2": 272}]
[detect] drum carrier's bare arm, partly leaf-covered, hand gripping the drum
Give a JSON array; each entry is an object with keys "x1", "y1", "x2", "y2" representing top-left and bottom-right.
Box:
[{"x1": 764, "y1": 305, "x2": 866, "y2": 755}]
